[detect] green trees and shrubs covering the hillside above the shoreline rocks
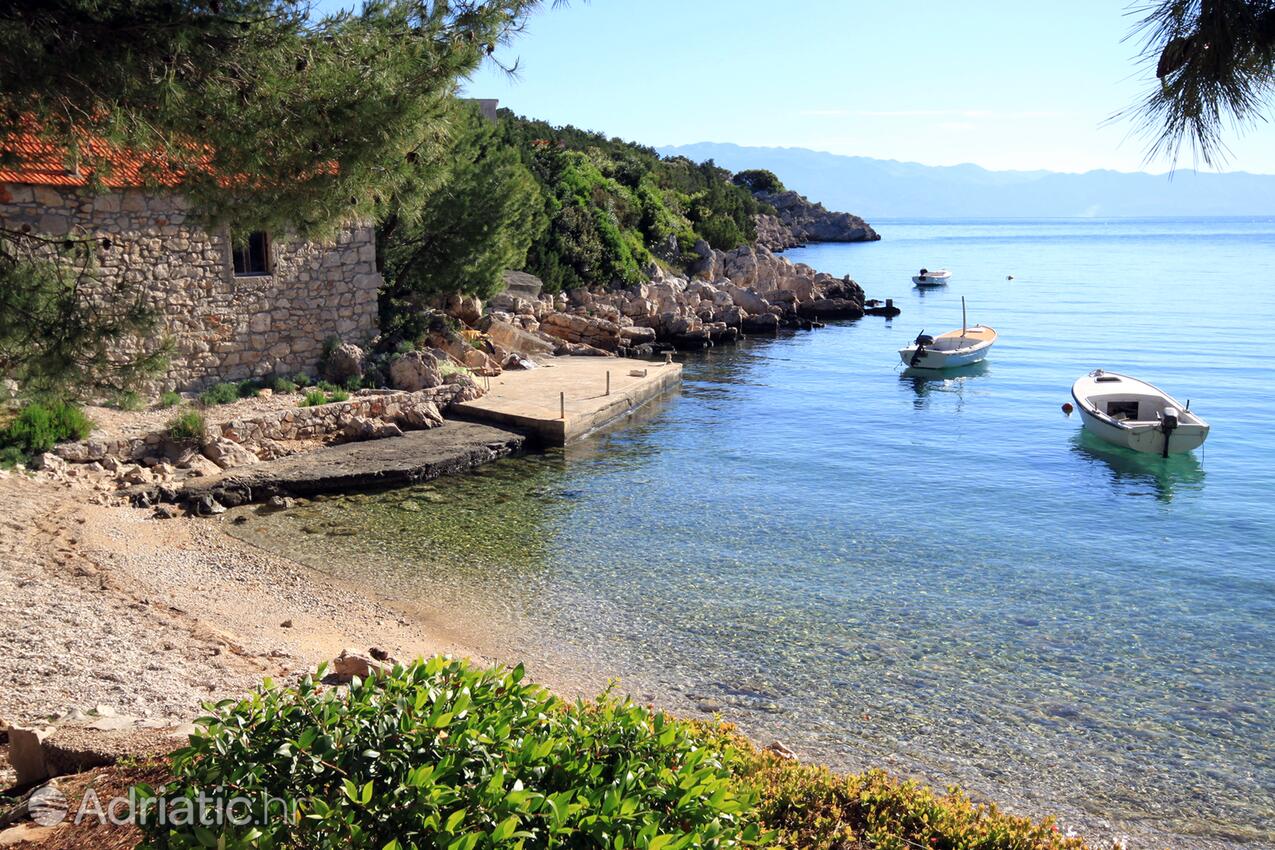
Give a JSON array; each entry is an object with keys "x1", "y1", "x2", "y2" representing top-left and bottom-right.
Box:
[{"x1": 379, "y1": 108, "x2": 778, "y2": 316}]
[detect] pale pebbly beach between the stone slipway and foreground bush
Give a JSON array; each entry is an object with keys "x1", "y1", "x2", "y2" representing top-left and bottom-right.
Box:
[{"x1": 0, "y1": 474, "x2": 566, "y2": 739}]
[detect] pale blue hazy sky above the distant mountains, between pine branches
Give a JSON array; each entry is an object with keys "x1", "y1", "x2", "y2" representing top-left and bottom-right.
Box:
[{"x1": 453, "y1": 0, "x2": 1275, "y2": 173}]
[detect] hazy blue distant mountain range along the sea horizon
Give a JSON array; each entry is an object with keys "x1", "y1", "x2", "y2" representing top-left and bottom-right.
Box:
[{"x1": 658, "y1": 141, "x2": 1275, "y2": 223}]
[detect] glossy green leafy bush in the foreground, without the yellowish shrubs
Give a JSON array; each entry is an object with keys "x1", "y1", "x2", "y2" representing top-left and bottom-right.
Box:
[{"x1": 146, "y1": 658, "x2": 764, "y2": 850}]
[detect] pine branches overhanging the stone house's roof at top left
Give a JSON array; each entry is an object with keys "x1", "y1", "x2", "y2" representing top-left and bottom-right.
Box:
[{"x1": 0, "y1": 0, "x2": 537, "y2": 234}]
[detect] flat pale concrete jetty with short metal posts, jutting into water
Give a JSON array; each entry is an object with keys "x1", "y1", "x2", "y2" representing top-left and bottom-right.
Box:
[{"x1": 450, "y1": 357, "x2": 682, "y2": 446}]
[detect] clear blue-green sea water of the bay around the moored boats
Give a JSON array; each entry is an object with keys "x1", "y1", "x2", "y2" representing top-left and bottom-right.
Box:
[{"x1": 236, "y1": 219, "x2": 1275, "y2": 847}]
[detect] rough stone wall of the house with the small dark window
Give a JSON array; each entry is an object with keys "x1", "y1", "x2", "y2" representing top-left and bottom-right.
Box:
[{"x1": 0, "y1": 184, "x2": 381, "y2": 390}]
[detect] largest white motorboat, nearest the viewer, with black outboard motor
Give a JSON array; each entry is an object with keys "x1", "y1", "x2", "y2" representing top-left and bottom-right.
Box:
[{"x1": 1071, "y1": 370, "x2": 1209, "y2": 457}]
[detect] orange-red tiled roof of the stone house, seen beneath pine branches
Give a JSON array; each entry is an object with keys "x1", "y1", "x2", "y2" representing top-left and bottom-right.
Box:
[{"x1": 0, "y1": 133, "x2": 181, "y2": 189}]
